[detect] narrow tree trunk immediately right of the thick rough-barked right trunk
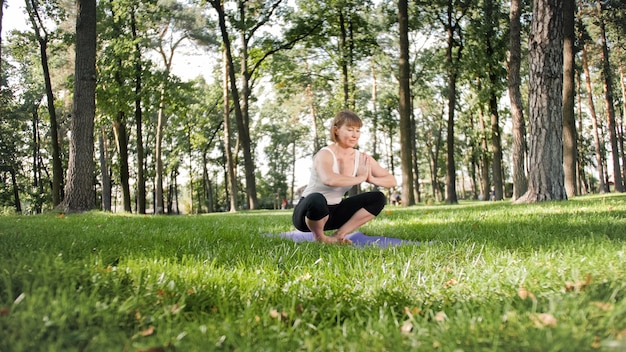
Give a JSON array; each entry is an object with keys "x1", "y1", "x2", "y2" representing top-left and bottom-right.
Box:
[{"x1": 563, "y1": 0, "x2": 578, "y2": 197}]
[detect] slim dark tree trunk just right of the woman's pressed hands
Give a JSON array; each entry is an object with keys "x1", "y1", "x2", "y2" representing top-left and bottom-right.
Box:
[{"x1": 398, "y1": 0, "x2": 415, "y2": 206}]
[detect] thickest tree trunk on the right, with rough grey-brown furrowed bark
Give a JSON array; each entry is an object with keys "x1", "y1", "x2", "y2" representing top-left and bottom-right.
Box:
[{"x1": 518, "y1": 0, "x2": 567, "y2": 202}]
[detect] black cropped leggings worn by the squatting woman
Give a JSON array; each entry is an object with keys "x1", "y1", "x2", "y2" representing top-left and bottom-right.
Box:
[{"x1": 293, "y1": 191, "x2": 387, "y2": 232}]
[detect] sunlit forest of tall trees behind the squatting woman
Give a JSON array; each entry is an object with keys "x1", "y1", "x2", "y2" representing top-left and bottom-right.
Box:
[{"x1": 0, "y1": 0, "x2": 626, "y2": 214}]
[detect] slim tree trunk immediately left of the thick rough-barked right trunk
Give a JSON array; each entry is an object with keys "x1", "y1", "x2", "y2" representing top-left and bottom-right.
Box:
[{"x1": 508, "y1": 0, "x2": 528, "y2": 200}]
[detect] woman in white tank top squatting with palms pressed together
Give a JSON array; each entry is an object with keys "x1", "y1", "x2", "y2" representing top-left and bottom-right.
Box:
[{"x1": 293, "y1": 110, "x2": 396, "y2": 243}]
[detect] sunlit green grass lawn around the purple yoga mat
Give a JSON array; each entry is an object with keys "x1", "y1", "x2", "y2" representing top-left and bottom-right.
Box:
[{"x1": 0, "y1": 195, "x2": 626, "y2": 352}]
